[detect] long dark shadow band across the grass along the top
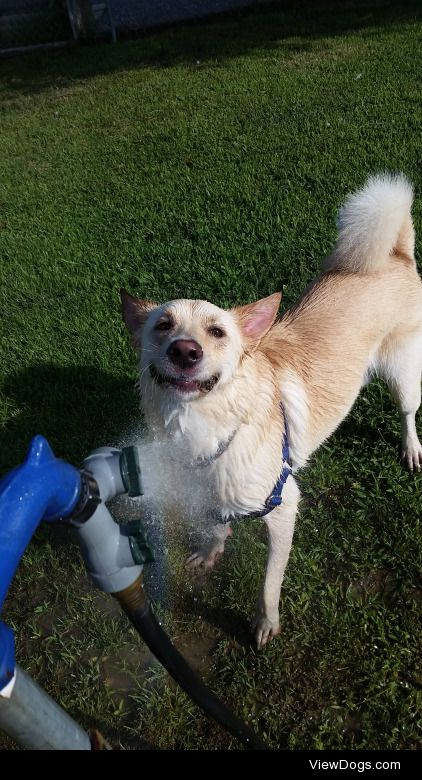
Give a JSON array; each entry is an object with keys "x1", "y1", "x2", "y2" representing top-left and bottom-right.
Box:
[{"x1": 0, "y1": 0, "x2": 421, "y2": 98}]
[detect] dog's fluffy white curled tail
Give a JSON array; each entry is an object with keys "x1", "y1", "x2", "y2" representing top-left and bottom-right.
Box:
[{"x1": 324, "y1": 173, "x2": 415, "y2": 273}]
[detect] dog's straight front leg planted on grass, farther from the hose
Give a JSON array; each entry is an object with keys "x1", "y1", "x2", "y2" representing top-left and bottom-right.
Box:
[{"x1": 252, "y1": 476, "x2": 300, "y2": 649}]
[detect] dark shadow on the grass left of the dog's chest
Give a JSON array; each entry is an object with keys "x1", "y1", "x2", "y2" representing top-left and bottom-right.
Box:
[{"x1": 0, "y1": 364, "x2": 140, "y2": 473}]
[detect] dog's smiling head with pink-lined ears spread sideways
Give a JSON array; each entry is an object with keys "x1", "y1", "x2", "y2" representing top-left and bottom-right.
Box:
[{"x1": 121, "y1": 291, "x2": 281, "y2": 402}]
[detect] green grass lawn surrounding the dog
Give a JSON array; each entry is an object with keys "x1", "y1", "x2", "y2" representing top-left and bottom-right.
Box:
[{"x1": 0, "y1": 0, "x2": 422, "y2": 749}]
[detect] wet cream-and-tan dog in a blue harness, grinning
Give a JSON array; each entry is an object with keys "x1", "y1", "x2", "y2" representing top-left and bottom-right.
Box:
[{"x1": 122, "y1": 174, "x2": 422, "y2": 648}]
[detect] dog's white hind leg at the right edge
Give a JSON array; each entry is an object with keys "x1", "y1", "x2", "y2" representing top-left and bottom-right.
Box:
[{"x1": 376, "y1": 330, "x2": 422, "y2": 472}]
